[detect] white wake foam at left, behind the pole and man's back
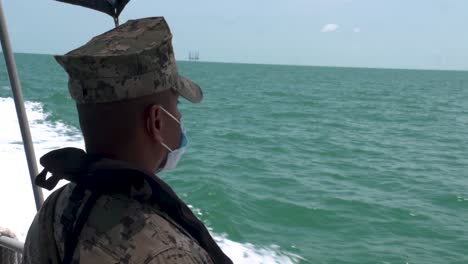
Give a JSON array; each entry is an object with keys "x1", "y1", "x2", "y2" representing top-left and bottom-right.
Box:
[{"x1": 0, "y1": 98, "x2": 83, "y2": 240}]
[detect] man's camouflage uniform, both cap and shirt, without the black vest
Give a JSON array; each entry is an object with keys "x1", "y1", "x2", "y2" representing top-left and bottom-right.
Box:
[{"x1": 23, "y1": 18, "x2": 231, "y2": 264}]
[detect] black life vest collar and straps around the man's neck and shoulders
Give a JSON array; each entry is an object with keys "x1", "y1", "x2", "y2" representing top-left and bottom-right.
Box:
[{"x1": 35, "y1": 148, "x2": 232, "y2": 264}]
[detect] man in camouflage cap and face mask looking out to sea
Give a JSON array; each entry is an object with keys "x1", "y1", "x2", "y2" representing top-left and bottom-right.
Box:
[{"x1": 23, "y1": 18, "x2": 232, "y2": 264}]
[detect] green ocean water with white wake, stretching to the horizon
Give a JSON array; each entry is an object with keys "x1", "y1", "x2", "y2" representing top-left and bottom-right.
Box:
[{"x1": 0, "y1": 54, "x2": 468, "y2": 264}]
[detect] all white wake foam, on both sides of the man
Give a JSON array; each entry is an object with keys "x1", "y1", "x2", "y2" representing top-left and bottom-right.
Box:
[{"x1": 0, "y1": 98, "x2": 300, "y2": 264}]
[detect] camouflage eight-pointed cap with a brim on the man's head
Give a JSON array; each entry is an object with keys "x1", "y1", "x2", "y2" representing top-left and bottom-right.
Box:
[{"x1": 55, "y1": 17, "x2": 203, "y2": 104}]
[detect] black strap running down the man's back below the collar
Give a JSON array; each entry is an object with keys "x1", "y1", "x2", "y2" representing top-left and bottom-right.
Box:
[{"x1": 60, "y1": 185, "x2": 100, "y2": 264}]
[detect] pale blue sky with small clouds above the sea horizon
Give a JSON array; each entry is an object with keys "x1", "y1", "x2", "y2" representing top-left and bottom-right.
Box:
[{"x1": 0, "y1": 0, "x2": 468, "y2": 70}]
